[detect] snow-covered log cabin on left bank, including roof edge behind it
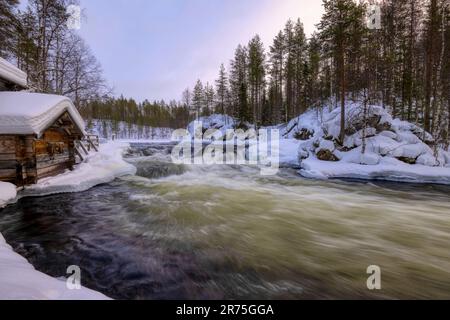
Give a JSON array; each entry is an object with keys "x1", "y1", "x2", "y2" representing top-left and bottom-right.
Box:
[{"x1": 0, "y1": 60, "x2": 86, "y2": 186}]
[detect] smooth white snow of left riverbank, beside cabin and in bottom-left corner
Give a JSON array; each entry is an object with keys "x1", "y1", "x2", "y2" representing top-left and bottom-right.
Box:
[{"x1": 0, "y1": 142, "x2": 136, "y2": 300}]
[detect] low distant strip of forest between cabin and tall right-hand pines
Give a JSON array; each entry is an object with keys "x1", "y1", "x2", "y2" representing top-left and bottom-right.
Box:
[{"x1": 81, "y1": 96, "x2": 189, "y2": 129}]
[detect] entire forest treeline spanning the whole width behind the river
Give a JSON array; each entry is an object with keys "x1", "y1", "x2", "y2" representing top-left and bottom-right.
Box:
[{"x1": 0, "y1": 0, "x2": 450, "y2": 145}]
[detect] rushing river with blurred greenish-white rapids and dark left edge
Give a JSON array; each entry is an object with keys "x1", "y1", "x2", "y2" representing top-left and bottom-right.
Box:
[{"x1": 0, "y1": 144, "x2": 450, "y2": 299}]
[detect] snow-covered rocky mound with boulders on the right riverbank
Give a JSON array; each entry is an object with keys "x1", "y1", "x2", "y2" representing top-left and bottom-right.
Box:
[{"x1": 294, "y1": 103, "x2": 450, "y2": 184}]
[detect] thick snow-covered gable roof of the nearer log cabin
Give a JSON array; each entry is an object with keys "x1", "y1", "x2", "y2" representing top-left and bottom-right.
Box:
[{"x1": 0, "y1": 92, "x2": 85, "y2": 136}]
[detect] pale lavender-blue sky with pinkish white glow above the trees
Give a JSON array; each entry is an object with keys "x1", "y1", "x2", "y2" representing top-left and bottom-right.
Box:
[{"x1": 79, "y1": 0, "x2": 323, "y2": 101}]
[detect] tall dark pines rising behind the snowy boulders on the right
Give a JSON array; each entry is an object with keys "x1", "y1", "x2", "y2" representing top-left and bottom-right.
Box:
[{"x1": 182, "y1": 0, "x2": 450, "y2": 143}]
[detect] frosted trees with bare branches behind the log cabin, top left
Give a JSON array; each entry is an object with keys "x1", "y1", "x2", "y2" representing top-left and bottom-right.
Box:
[{"x1": 0, "y1": 0, "x2": 110, "y2": 109}]
